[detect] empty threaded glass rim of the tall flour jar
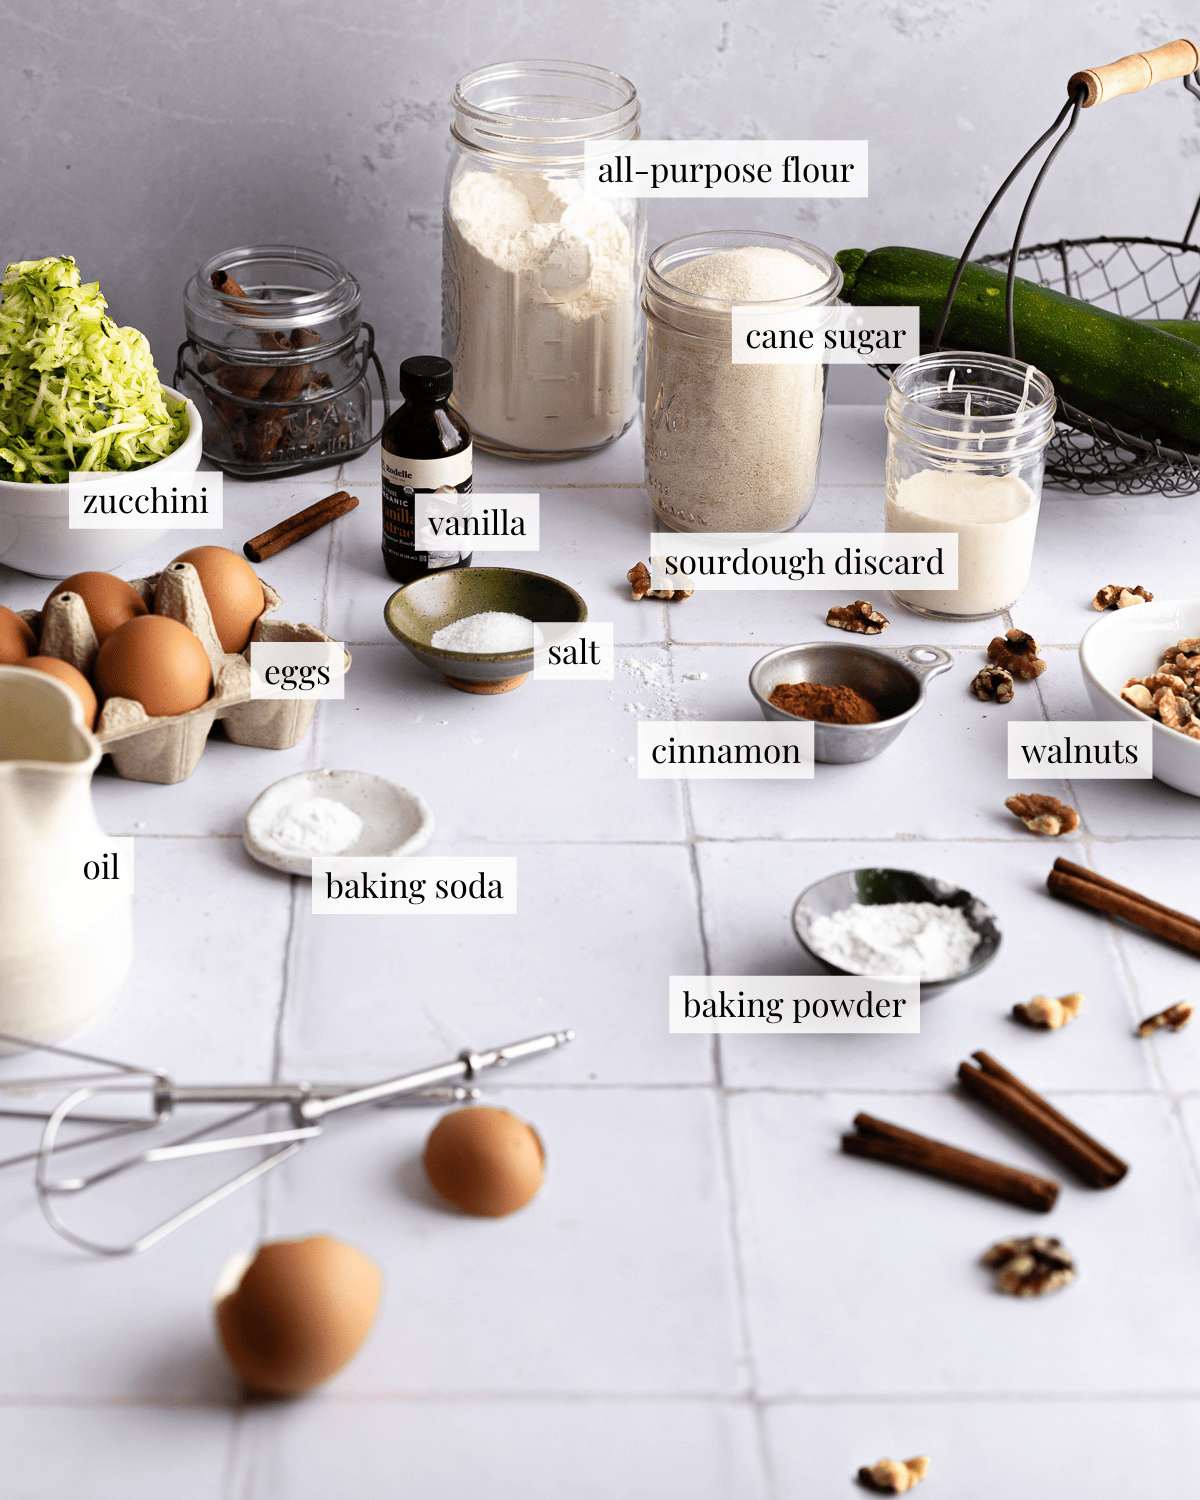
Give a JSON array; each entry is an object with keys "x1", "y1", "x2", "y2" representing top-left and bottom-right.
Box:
[{"x1": 450, "y1": 57, "x2": 642, "y2": 156}]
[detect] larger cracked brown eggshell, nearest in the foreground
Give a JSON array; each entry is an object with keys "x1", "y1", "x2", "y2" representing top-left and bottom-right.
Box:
[{"x1": 216, "y1": 1235, "x2": 383, "y2": 1397}]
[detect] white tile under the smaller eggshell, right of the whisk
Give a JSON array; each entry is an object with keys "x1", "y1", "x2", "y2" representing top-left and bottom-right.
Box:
[{"x1": 269, "y1": 1077, "x2": 746, "y2": 1397}]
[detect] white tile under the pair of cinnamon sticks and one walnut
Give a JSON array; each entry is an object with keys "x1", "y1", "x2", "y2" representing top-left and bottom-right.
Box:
[{"x1": 731, "y1": 1091, "x2": 1200, "y2": 1392}]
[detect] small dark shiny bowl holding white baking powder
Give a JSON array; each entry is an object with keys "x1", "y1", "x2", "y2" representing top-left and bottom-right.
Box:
[{"x1": 792, "y1": 869, "x2": 1001, "y2": 999}]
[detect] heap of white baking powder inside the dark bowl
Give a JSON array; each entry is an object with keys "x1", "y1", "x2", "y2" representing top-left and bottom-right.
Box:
[{"x1": 807, "y1": 902, "x2": 980, "y2": 980}]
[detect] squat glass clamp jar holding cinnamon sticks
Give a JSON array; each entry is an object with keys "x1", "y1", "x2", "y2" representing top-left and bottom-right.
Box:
[{"x1": 176, "y1": 245, "x2": 389, "y2": 479}]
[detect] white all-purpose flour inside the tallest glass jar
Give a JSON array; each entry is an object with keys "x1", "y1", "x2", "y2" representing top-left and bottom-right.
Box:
[{"x1": 446, "y1": 171, "x2": 638, "y2": 453}]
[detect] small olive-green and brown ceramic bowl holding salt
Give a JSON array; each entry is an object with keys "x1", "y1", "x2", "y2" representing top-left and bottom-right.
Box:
[{"x1": 384, "y1": 567, "x2": 588, "y2": 693}]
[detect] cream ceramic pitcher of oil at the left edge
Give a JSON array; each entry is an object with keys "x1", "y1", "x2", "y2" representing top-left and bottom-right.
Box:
[{"x1": 0, "y1": 666, "x2": 134, "y2": 1041}]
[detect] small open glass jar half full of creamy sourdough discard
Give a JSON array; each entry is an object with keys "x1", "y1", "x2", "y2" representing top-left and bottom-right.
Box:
[{"x1": 885, "y1": 353, "x2": 1055, "y2": 620}]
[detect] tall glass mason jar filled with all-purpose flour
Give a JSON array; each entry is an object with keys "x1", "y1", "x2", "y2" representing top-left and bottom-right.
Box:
[{"x1": 443, "y1": 62, "x2": 645, "y2": 459}]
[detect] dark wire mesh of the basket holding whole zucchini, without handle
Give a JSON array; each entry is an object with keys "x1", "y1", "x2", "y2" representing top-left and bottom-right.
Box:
[{"x1": 980, "y1": 234, "x2": 1200, "y2": 495}]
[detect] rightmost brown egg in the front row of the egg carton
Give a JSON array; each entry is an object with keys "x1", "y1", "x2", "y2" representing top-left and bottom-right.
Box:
[{"x1": 92, "y1": 615, "x2": 213, "y2": 719}]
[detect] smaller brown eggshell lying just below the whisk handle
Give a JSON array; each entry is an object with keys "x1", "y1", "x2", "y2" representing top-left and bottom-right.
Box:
[{"x1": 425, "y1": 1104, "x2": 545, "y2": 1218}]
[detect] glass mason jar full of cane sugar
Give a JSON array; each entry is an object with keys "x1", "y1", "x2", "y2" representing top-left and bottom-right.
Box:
[{"x1": 642, "y1": 231, "x2": 842, "y2": 531}]
